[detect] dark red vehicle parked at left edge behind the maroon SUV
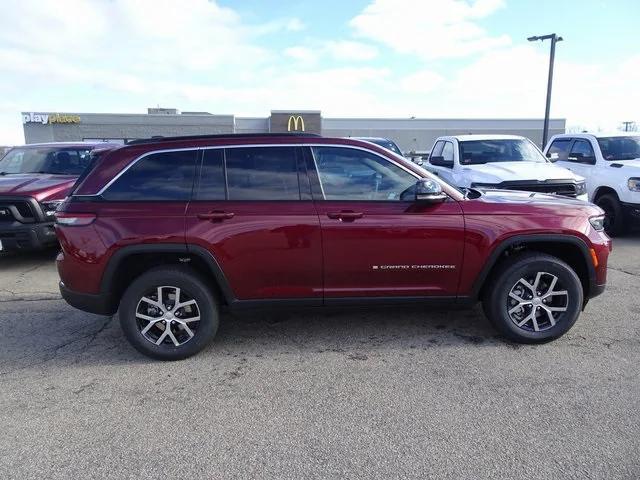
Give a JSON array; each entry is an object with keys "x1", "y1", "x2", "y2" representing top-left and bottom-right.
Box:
[{"x1": 0, "y1": 143, "x2": 114, "y2": 251}]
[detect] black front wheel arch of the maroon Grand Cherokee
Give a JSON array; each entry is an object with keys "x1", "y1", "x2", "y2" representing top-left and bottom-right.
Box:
[{"x1": 472, "y1": 235, "x2": 596, "y2": 300}]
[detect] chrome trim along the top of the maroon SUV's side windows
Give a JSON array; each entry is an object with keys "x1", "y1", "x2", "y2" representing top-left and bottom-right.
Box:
[{"x1": 73, "y1": 142, "x2": 450, "y2": 198}]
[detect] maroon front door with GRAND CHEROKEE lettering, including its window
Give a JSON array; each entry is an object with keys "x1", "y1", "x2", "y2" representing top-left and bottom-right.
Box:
[{"x1": 307, "y1": 146, "x2": 464, "y2": 303}]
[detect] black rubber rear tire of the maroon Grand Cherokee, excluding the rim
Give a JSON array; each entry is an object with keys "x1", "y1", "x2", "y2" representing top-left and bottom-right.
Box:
[{"x1": 118, "y1": 268, "x2": 219, "y2": 360}]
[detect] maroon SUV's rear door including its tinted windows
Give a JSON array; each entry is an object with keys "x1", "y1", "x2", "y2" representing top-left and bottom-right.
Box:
[{"x1": 186, "y1": 145, "x2": 322, "y2": 304}]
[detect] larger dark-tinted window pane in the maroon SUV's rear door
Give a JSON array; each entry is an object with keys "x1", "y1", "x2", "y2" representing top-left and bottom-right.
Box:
[{"x1": 225, "y1": 147, "x2": 300, "y2": 200}]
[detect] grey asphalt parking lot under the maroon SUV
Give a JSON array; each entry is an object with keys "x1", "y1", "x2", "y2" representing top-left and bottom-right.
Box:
[{"x1": 0, "y1": 235, "x2": 640, "y2": 479}]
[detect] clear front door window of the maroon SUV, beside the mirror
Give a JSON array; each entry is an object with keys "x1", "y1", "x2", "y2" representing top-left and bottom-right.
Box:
[{"x1": 313, "y1": 147, "x2": 417, "y2": 200}]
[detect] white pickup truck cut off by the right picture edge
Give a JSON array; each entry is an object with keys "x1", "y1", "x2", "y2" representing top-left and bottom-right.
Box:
[{"x1": 544, "y1": 133, "x2": 640, "y2": 235}]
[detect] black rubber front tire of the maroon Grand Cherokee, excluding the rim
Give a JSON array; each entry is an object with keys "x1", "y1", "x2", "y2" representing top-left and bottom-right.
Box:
[{"x1": 487, "y1": 257, "x2": 584, "y2": 343}]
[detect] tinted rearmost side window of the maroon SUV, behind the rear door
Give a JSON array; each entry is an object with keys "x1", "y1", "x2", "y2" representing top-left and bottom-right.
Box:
[{"x1": 102, "y1": 150, "x2": 197, "y2": 202}]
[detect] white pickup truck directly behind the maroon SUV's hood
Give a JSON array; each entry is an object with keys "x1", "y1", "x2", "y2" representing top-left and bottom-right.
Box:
[{"x1": 422, "y1": 135, "x2": 587, "y2": 200}]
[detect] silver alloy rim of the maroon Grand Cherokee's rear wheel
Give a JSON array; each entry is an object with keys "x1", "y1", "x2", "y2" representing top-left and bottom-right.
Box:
[{"x1": 136, "y1": 285, "x2": 200, "y2": 347}]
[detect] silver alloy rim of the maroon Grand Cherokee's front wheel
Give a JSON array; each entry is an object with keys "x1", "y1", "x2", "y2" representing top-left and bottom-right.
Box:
[{"x1": 507, "y1": 272, "x2": 569, "y2": 332}]
